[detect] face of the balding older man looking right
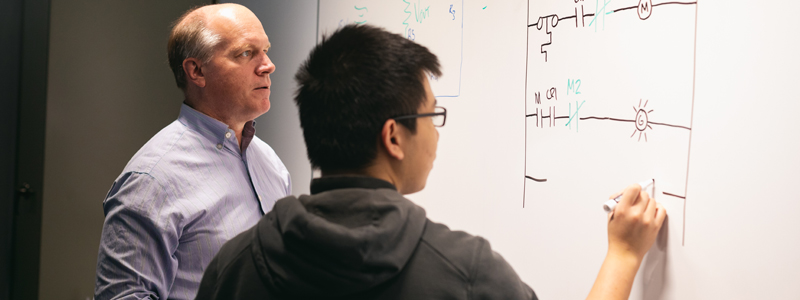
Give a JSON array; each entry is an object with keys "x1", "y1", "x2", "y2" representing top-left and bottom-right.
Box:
[{"x1": 203, "y1": 7, "x2": 275, "y2": 122}]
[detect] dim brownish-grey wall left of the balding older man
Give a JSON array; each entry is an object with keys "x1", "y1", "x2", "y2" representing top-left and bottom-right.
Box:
[{"x1": 39, "y1": 0, "x2": 210, "y2": 300}]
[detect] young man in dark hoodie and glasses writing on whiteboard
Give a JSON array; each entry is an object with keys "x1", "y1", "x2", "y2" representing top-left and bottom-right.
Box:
[{"x1": 198, "y1": 25, "x2": 666, "y2": 299}]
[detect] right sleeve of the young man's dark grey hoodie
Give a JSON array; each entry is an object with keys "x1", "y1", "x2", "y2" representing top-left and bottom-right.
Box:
[{"x1": 470, "y1": 239, "x2": 538, "y2": 300}]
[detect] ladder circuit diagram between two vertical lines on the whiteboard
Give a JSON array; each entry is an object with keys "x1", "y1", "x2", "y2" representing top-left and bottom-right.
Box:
[{"x1": 522, "y1": 0, "x2": 697, "y2": 243}]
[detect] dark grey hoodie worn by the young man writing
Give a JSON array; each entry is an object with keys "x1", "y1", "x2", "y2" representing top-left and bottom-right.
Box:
[{"x1": 196, "y1": 177, "x2": 536, "y2": 300}]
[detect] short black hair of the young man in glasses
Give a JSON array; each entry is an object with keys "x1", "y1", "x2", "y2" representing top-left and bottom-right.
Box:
[{"x1": 295, "y1": 25, "x2": 441, "y2": 172}]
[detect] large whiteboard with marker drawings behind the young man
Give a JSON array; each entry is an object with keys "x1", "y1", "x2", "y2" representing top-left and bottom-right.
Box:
[{"x1": 242, "y1": 0, "x2": 800, "y2": 299}]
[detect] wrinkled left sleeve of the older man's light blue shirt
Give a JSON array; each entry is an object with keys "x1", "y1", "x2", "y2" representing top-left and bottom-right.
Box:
[{"x1": 95, "y1": 172, "x2": 180, "y2": 300}]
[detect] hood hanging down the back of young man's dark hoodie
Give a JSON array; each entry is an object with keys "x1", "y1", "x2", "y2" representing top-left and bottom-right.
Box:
[{"x1": 252, "y1": 176, "x2": 426, "y2": 297}]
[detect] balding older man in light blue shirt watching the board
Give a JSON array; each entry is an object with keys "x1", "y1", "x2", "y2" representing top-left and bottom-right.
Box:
[{"x1": 95, "y1": 4, "x2": 291, "y2": 299}]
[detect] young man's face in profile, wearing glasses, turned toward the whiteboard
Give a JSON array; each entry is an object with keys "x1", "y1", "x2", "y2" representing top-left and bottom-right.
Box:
[{"x1": 401, "y1": 76, "x2": 439, "y2": 194}]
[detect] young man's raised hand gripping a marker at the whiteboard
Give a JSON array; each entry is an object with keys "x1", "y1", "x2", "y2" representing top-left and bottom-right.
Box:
[{"x1": 608, "y1": 184, "x2": 667, "y2": 261}]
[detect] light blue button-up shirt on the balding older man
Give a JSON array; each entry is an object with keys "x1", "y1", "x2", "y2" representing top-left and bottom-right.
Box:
[{"x1": 95, "y1": 104, "x2": 291, "y2": 300}]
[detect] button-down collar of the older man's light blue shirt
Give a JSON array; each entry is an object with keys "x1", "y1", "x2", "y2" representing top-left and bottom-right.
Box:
[{"x1": 178, "y1": 103, "x2": 256, "y2": 149}]
